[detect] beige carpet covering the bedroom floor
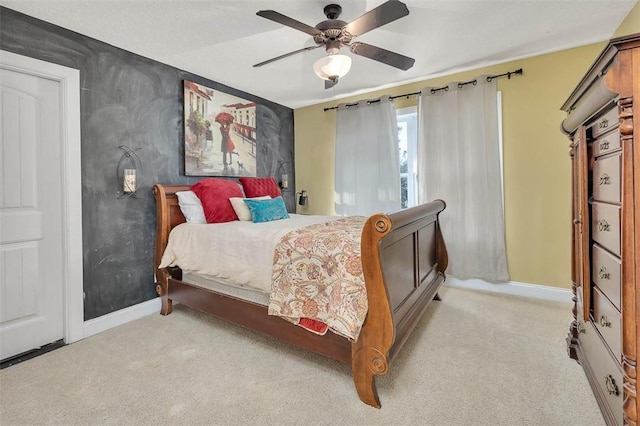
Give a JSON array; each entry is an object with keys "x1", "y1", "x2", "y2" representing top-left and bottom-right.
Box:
[{"x1": 0, "y1": 287, "x2": 604, "y2": 426}]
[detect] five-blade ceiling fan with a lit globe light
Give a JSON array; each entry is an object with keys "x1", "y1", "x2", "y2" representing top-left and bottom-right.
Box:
[{"x1": 254, "y1": 0, "x2": 415, "y2": 89}]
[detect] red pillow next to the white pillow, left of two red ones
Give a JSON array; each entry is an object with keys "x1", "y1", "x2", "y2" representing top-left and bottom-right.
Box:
[{"x1": 189, "y1": 179, "x2": 242, "y2": 223}]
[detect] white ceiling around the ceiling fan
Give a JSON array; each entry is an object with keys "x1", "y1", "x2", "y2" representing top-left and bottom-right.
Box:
[{"x1": 0, "y1": 0, "x2": 637, "y2": 108}]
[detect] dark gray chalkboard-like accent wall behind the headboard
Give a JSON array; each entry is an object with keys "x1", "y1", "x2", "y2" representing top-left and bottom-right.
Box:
[{"x1": 0, "y1": 7, "x2": 295, "y2": 320}]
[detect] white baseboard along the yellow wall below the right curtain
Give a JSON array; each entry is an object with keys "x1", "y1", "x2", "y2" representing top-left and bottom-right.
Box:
[{"x1": 445, "y1": 277, "x2": 573, "y2": 304}]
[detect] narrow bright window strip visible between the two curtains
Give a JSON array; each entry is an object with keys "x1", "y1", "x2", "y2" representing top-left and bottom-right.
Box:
[{"x1": 396, "y1": 107, "x2": 418, "y2": 209}]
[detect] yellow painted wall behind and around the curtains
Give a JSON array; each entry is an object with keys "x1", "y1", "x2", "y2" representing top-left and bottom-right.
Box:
[{"x1": 294, "y1": 4, "x2": 640, "y2": 288}]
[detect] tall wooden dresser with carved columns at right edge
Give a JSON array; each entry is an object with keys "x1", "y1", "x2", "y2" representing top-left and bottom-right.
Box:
[{"x1": 562, "y1": 34, "x2": 640, "y2": 425}]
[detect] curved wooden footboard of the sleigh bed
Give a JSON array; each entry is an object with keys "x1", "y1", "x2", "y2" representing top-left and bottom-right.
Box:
[{"x1": 351, "y1": 200, "x2": 448, "y2": 408}]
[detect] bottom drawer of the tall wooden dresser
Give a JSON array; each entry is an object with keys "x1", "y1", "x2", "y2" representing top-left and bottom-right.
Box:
[{"x1": 579, "y1": 322, "x2": 622, "y2": 425}]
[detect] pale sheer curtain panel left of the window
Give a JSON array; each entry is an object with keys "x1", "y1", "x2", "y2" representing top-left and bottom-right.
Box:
[{"x1": 334, "y1": 98, "x2": 401, "y2": 216}]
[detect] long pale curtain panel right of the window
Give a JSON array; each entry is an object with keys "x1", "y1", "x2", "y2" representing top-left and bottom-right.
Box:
[{"x1": 418, "y1": 76, "x2": 509, "y2": 282}]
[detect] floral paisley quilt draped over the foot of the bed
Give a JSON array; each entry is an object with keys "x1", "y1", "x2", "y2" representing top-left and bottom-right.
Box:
[{"x1": 269, "y1": 216, "x2": 368, "y2": 341}]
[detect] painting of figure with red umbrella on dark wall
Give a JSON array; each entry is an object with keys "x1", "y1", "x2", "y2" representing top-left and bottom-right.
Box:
[{"x1": 184, "y1": 80, "x2": 256, "y2": 176}]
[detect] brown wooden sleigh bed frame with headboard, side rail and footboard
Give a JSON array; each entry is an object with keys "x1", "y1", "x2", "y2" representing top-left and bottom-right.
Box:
[{"x1": 153, "y1": 184, "x2": 448, "y2": 408}]
